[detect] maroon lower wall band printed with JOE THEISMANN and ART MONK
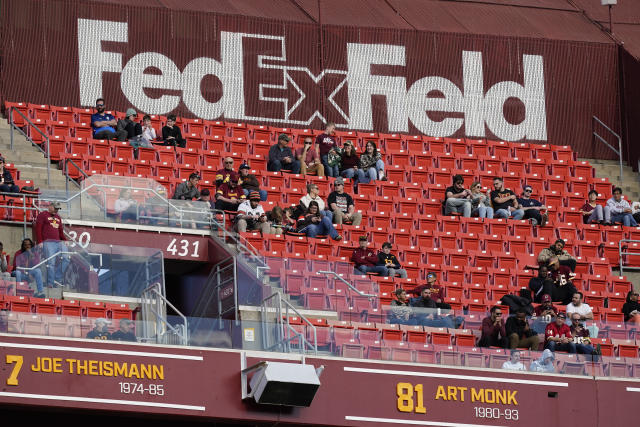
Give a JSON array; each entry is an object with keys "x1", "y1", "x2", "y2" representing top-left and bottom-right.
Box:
[{"x1": 0, "y1": 335, "x2": 640, "y2": 427}]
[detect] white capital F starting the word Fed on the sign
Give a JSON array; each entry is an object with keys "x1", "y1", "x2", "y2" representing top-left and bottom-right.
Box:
[{"x1": 78, "y1": 19, "x2": 128, "y2": 105}]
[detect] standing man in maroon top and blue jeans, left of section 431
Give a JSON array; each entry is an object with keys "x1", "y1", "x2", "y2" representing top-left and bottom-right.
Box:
[{"x1": 35, "y1": 202, "x2": 69, "y2": 288}]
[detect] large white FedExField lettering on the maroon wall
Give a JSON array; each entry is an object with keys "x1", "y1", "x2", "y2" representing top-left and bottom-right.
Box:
[{"x1": 77, "y1": 19, "x2": 547, "y2": 141}]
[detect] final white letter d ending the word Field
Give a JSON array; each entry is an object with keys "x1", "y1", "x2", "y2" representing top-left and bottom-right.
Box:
[{"x1": 484, "y1": 55, "x2": 547, "y2": 141}]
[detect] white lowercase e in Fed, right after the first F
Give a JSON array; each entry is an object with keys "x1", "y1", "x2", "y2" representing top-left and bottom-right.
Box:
[{"x1": 120, "y1": 52, "x2": 182, "y2": 114}]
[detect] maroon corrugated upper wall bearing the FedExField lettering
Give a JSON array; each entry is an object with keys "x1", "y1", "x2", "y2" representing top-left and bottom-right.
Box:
[{"x1": 0, "y1": 0, "x2": 620, "y2": 158}]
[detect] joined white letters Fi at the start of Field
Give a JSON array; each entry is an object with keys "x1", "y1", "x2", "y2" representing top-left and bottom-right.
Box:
[{"x1": 347, "y1": 43, "x2": 409, "y2": 132}]
